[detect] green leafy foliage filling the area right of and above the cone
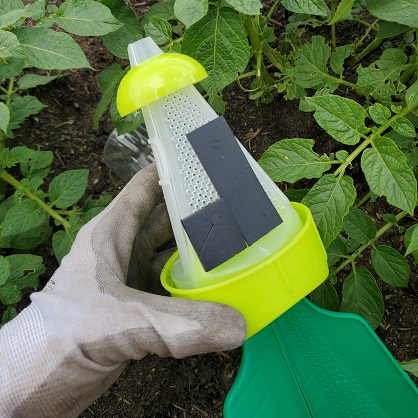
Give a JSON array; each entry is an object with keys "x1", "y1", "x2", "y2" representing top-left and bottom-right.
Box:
[{"x1": 94, "y1": 0, "x2": 418, "y2": 336}]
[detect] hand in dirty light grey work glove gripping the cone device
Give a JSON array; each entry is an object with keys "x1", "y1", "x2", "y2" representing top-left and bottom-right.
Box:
[{"x1": 0, "y1": 165, "x2": 246, "y2": 418}]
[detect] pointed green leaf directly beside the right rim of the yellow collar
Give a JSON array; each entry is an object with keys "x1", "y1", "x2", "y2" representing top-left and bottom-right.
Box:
[{"x1": 302, "y1": 174, "x2": 356, "y2": 248}]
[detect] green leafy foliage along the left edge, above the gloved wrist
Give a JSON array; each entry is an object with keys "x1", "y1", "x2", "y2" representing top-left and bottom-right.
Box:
[{"x1": 0, "y1": 0, "x2": 122, "y2": 324}]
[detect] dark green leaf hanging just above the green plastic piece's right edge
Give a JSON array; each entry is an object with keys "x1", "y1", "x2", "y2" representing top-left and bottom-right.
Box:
[{"x1": 340, "y1": 267, "x2": 384, "y2": 329}]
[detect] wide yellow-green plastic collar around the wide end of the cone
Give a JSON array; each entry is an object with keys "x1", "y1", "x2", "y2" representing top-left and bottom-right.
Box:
[{"x1": 161, "y1": 203, "x2": 328, "y2": 338}]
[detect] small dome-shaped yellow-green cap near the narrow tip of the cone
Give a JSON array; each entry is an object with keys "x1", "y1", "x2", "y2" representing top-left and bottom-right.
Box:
[{"x1": 116, "y1": 52, "x2": 208, "y2": 116}]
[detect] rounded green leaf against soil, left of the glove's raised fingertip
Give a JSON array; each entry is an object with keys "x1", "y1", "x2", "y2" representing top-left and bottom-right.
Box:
[{"x1": 48, "y1": 169, "x2": 89, "y2": 209}]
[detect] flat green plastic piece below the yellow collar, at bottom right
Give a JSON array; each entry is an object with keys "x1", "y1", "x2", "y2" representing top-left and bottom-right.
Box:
[{"x1": 224, "y1": 298, "x2": 418, "y2": 418}]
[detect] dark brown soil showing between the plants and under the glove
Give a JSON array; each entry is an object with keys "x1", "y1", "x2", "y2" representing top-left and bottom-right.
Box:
[{"x1": 5, "y1": 3, "x2": 418, "y2": 418}]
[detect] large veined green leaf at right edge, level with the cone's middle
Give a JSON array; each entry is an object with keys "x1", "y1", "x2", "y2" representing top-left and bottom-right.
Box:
[{"x1": 361, "y1": 137, "x2": 417, "y2": 215}]
